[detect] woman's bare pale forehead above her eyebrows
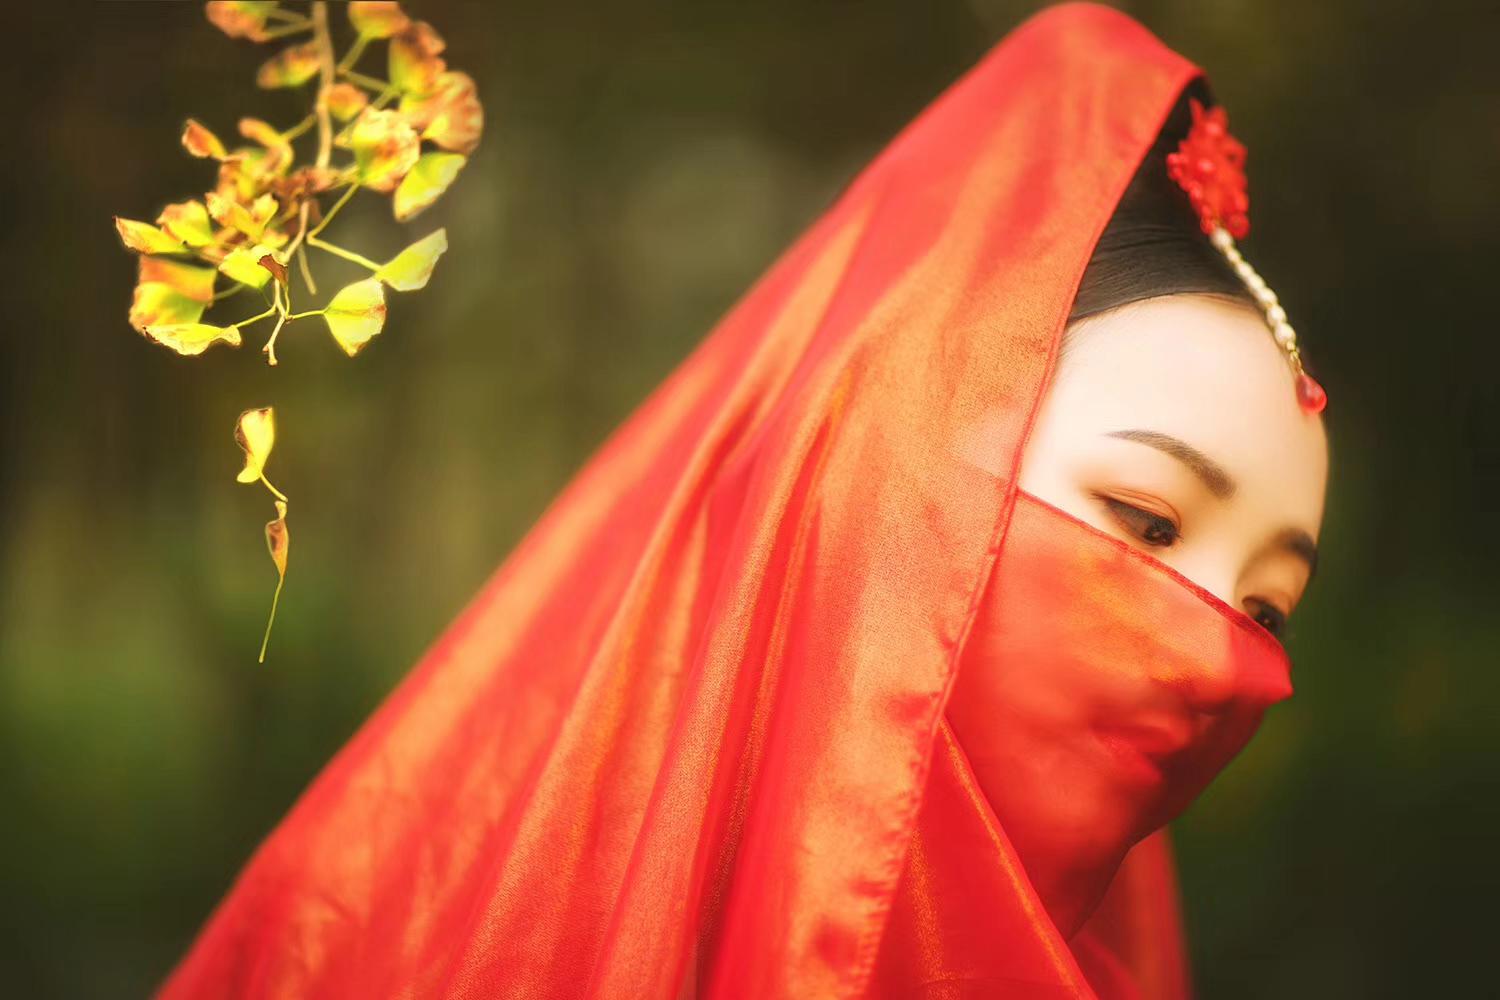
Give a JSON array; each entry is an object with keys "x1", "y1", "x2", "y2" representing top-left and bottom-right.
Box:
[{"x1": 1047, "y1": 295, "x2": 1328, "y2": 537}]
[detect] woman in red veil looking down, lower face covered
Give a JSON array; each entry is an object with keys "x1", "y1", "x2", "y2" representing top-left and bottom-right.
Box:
[{"x1": 162, "y1": 4, "x2": 1326, "y2": 997}]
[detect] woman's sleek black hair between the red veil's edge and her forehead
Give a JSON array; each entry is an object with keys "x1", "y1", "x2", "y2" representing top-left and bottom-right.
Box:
[{"x1": 1068, "y1": 76, "x2": 1259, "y2": 324}]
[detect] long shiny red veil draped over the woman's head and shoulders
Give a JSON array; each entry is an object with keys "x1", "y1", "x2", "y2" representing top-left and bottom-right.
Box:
[{"x1": 161, "y1": 3, "x2": 1274, "y2": 1000}]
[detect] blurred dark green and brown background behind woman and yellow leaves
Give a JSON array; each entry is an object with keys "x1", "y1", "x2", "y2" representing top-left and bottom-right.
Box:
[{"x1": 0, "y1": 0, "x2": 1500, "y2": 999}]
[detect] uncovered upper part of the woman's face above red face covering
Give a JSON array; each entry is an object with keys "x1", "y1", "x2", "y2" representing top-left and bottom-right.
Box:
[{"x1": 1020, "y1": 295, "x2": 1328, "y2": 633}]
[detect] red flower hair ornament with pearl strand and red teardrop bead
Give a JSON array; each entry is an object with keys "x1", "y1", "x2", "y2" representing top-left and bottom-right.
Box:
[{"x1": 1167, "y1": 97, "x2": 1328, "y2": 414}]
